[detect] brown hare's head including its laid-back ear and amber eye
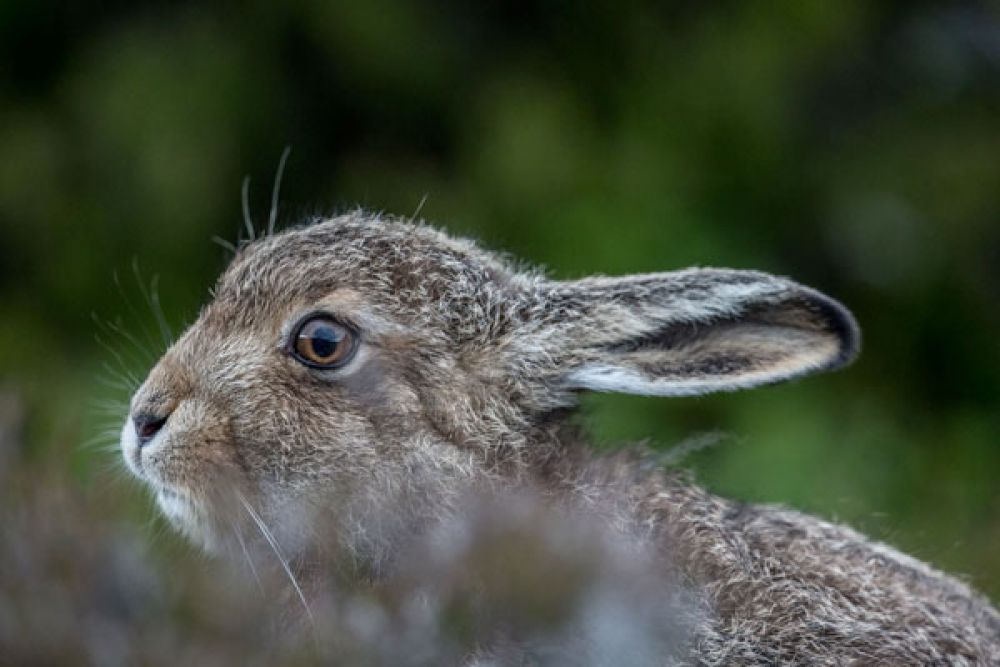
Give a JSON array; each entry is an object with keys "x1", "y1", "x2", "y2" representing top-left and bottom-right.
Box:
[{"x1": 122, "y1": 213, "x2": 858, "y2": 564}]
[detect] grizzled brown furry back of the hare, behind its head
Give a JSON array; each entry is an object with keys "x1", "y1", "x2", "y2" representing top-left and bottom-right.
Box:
[{"x1": 548, "y1": 448, "x2": 1000, "y2": 665}]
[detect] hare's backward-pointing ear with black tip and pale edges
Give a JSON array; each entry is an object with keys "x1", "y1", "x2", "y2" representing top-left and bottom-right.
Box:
[{"x1": 547, "y1": 269, "x2": 860, "y2": 396}]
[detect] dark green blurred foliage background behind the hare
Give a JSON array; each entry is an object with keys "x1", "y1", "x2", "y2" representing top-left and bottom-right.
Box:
[{"x1": 0, "y1": 0, "x2": 1000, "y2": 600}]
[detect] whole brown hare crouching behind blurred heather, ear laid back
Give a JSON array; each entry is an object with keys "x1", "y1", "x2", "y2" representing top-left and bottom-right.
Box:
[{"x1": 121, "y1": 212, "x2": 1000, "y2": 664}]
